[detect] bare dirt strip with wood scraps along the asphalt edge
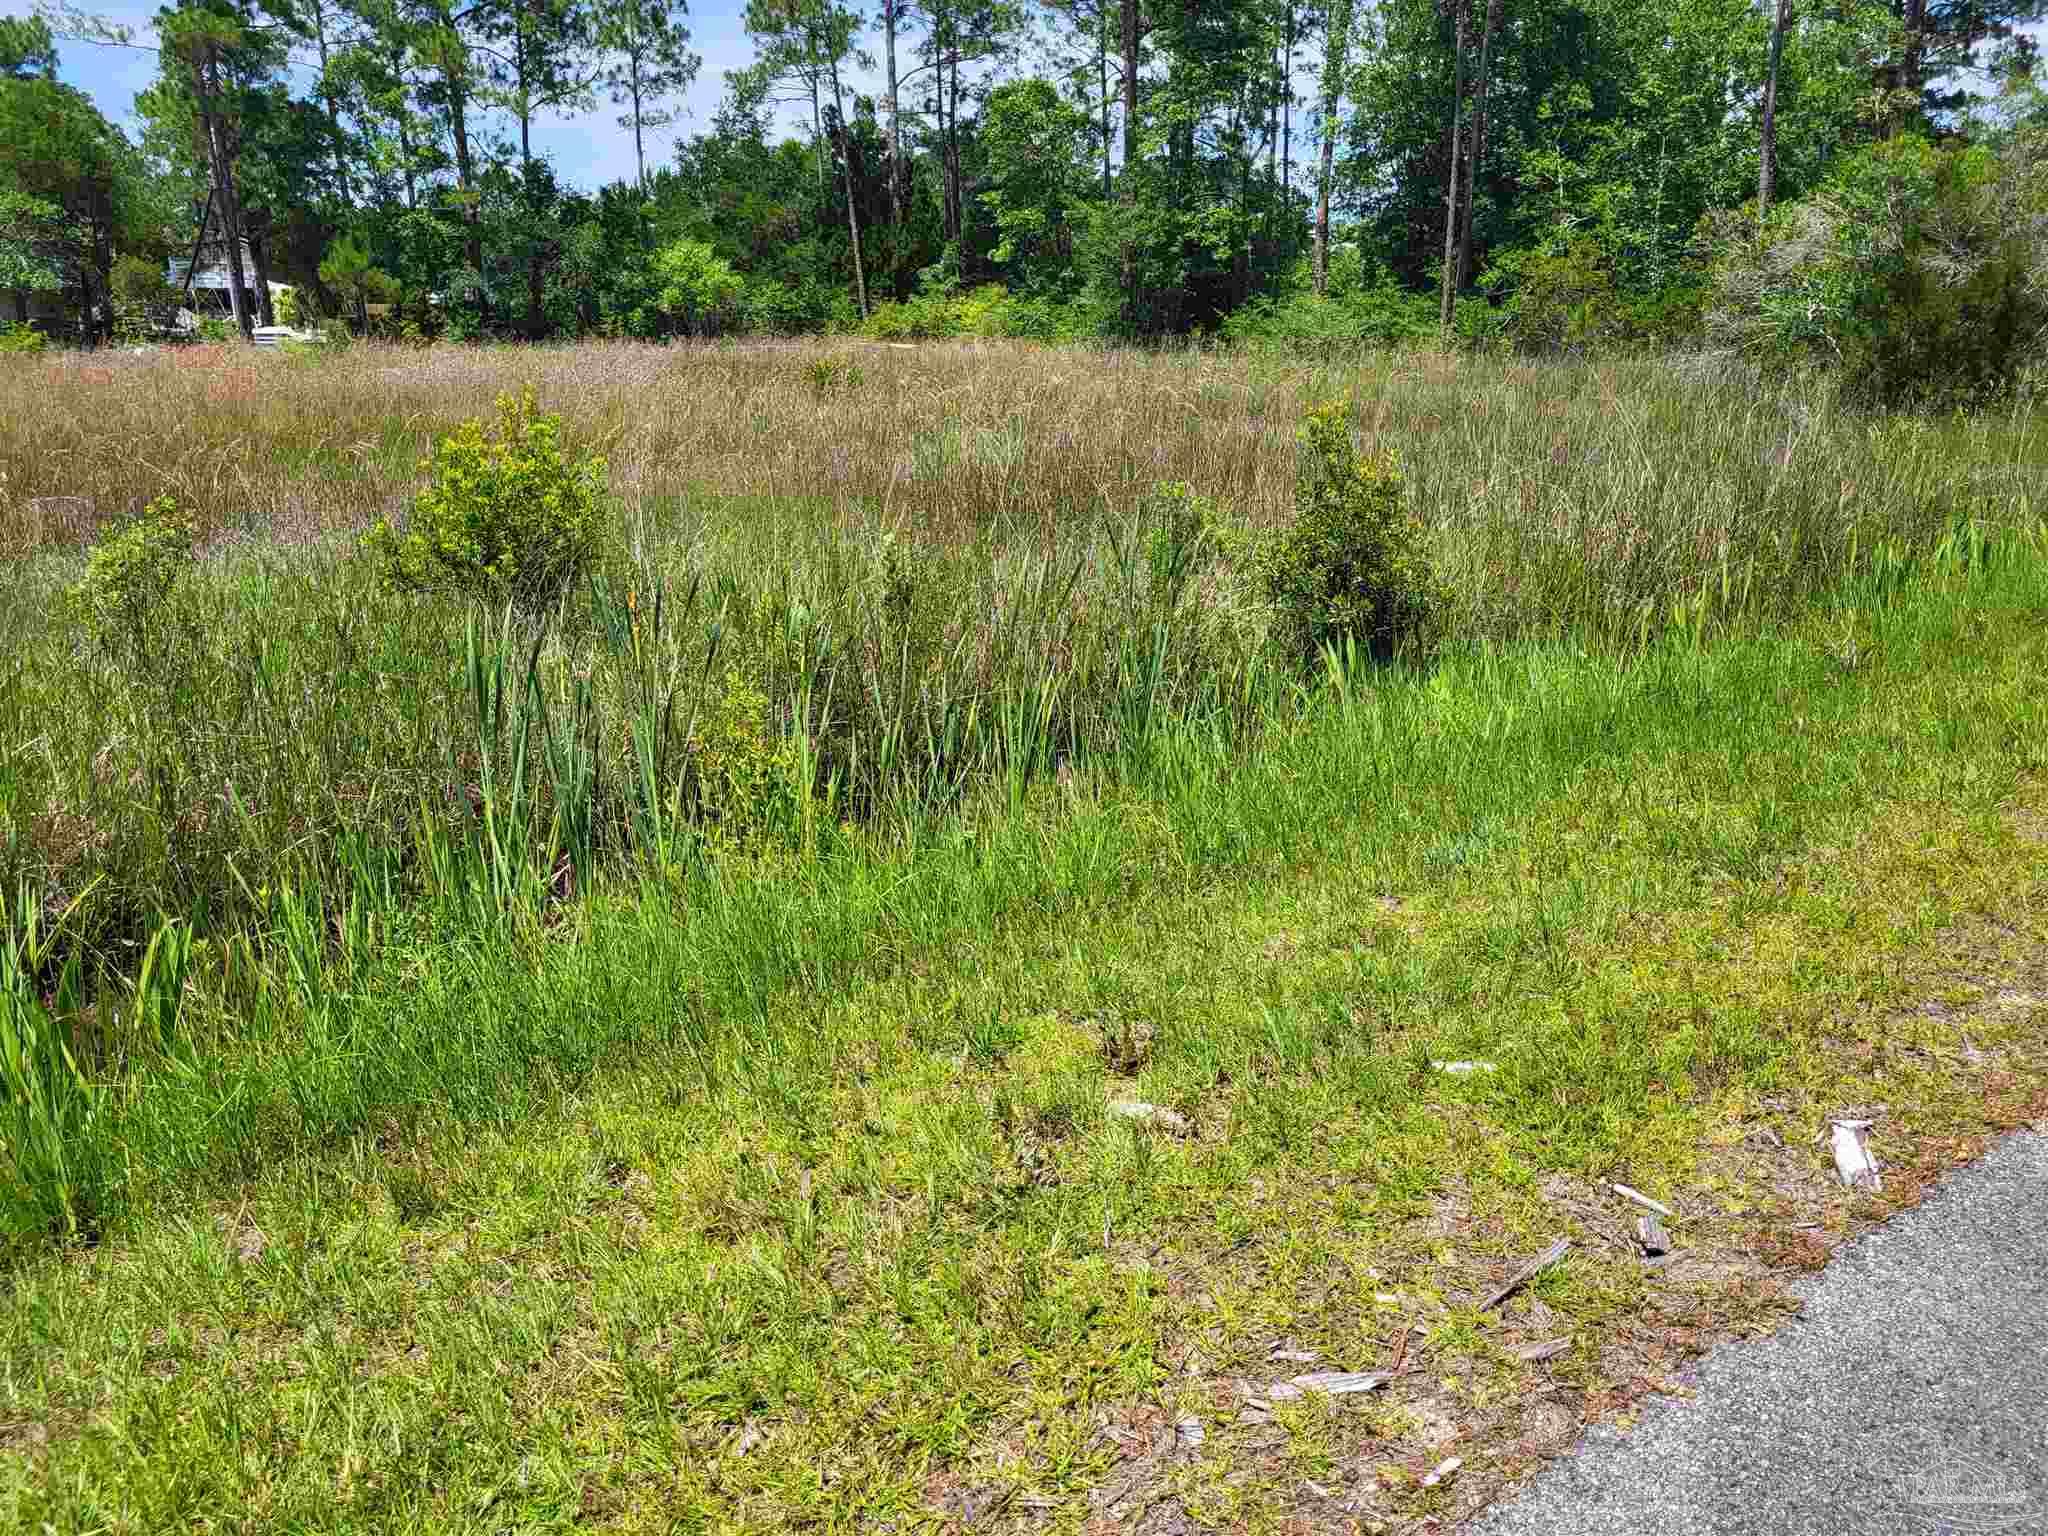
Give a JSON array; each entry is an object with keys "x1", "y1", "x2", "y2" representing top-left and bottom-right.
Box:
[{"x1": 1032, "y1": 925, "x2": 2048, "y2": 1534}]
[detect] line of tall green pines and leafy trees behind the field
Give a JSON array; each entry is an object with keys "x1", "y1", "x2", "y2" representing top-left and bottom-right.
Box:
[{"x1": 0, "y1": 0, "x2": 2048, "y2": 340}]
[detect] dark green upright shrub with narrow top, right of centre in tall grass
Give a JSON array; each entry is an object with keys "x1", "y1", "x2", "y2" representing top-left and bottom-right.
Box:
[{"x1": 1260, "y1": 401, "x2": 1448, "y2": 662}]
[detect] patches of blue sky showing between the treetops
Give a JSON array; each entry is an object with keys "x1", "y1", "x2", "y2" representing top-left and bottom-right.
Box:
[{"x1": 37, "y1": 0, "x2": 856, "y2": 186}]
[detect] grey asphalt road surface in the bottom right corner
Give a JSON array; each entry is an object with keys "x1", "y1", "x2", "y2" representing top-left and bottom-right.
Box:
[{"x1": 1470, "y1": 1135, "x2": 2048, "y2": 1536}]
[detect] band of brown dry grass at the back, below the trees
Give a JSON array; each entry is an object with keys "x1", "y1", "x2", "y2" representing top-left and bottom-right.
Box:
[{"x1": 0, "y1": 340, "x2": 2042, "y2": 631}]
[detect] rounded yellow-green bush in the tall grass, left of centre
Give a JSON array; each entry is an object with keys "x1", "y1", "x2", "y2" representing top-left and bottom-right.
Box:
[{"x1": 365, "y1": 389, "x2": 608, "y2": 612}]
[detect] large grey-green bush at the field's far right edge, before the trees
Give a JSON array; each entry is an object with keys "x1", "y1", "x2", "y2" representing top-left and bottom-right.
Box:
[{"x1": 1708, "y1": 133, "x2": 2048, "y2": 403}]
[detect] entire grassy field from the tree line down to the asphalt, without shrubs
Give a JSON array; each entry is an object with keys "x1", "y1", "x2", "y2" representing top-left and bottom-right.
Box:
[{"x1": 0, "y1": 346, "x2": 2048, "y2": 1532}]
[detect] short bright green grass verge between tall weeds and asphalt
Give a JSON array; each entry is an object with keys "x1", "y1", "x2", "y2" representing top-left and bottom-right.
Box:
[{"x1": 0, "y1": 514, "x2": 2048, "y2": 1532}]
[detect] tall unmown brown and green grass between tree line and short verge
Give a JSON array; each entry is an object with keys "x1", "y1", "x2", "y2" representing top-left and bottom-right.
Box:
[{"x1": 0, "y1": 342, "x2": 2044, "y2": 974}]
